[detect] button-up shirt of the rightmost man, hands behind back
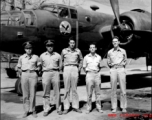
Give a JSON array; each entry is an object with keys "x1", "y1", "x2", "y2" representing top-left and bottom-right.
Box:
[{"x1": 107, "y1": 47, "x2": 127, "y2": 68}]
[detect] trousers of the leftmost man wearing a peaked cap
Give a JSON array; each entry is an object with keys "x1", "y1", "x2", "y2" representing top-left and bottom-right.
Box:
[{"x1": 21, "y1": 72, "x2": 38, "y2": 112}]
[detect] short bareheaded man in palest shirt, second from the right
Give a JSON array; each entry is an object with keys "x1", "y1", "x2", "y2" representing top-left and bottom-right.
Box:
[{"x1": 83, "y1": 44, "x2": 103, "y2": 114}]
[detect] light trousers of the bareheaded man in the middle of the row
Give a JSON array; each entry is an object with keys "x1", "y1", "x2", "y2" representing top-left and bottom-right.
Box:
[{"x1": 63, "y1": 66, "x2": 79, "y2": 110}]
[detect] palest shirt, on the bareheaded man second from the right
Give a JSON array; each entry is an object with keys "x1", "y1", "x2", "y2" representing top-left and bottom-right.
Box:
[{"x1": 83, "y1": 54, "x2": 102, "y2": 72}]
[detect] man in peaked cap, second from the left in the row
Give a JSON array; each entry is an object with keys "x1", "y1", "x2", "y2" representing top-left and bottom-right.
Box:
[{"x1": 40, "y1": 40, "x2": 62, "y2": 116}]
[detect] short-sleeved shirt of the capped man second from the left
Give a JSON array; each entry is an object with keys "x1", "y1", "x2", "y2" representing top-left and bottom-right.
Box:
[{"x1": 40, "y1": 52, "x2": 62, "y2": 71}]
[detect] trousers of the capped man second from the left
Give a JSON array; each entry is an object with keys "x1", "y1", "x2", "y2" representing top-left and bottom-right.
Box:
[{"x1": 42, "y1": 71, "x2": 61, "y2": 112}]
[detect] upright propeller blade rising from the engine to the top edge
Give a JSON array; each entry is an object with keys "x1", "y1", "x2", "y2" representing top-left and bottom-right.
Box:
[{"x1": 110, "y1": 0, "x2": 120, "y2": 25}]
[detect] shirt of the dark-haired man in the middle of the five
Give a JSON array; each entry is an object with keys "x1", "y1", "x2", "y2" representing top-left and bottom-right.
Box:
[{"x1": 61, "y1": 48, "x2": 83, "y2": 67}]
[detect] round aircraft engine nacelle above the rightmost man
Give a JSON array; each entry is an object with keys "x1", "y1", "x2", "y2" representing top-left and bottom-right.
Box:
[{"x1": 111, "y1": 9, "x2": 152, "y2": 45}]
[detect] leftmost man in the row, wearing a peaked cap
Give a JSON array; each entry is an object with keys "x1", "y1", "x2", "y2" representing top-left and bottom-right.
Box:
[{"x1": 17, "y1": 42, "x2": 40, "y2": 118}]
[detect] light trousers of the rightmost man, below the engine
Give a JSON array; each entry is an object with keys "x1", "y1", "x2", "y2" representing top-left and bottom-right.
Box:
[{"x1": 110, "y1": 68, "x2": 127, "y2": 109}]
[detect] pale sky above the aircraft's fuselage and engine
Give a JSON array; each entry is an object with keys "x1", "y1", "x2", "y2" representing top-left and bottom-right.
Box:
[{"x1": 0, "y1": 0, "x2": 151, "y2": 14}]
